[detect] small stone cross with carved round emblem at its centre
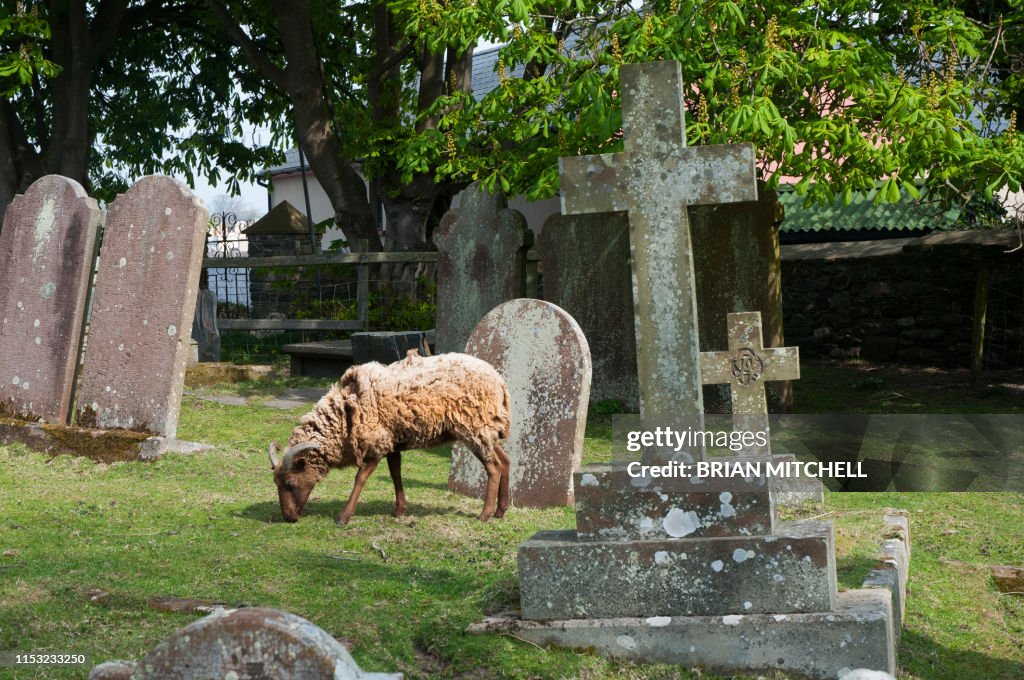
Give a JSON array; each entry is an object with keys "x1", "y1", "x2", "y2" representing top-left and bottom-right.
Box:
[{"x1": 700, "y1": 311, "x2": 800, "y2": 456}]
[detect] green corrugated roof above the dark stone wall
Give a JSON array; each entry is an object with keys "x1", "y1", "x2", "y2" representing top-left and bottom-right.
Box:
[{"x1": 775, "y1": 184, "x2": 961, "y2": 233}]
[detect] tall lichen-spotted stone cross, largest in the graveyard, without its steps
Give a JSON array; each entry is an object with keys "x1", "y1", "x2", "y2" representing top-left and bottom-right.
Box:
[{"x1": 559, "y1": 61, "x2": 758, "y2": 436}]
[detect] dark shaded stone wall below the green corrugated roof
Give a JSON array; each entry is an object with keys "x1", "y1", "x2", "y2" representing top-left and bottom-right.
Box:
[{"x1": 781, "y1": 231, "x2": 1024, "y2": 368}]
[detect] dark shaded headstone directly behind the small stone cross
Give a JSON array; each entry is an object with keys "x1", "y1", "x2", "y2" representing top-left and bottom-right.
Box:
[{"x1": 689, "y1": 183, "x2": 793, "y2": 413}]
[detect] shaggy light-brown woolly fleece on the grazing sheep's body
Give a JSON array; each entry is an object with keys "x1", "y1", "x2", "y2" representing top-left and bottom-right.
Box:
[{"x1": 288, "y1": 350, "x2": 511, "y2": 476}]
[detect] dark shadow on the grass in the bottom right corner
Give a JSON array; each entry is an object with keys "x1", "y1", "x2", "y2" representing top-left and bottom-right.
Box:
[{"x1": 898, "y1": 630, "x2": 1024, "y2": 680}]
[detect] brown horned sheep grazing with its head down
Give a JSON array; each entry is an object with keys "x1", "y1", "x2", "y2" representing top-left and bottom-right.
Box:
[{"x1": 270, "y1": 349, "x2": 511, "y2": 524}]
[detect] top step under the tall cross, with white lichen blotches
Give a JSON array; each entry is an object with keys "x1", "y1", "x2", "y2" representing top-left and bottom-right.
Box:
[{"x1": 573, "y1": 463, "x2": 775, "y2": 541}]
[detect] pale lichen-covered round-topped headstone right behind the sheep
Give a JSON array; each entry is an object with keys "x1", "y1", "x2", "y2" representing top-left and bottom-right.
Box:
[{"x1": 449, "y1": 299, "x2": 592, "y2": 508}]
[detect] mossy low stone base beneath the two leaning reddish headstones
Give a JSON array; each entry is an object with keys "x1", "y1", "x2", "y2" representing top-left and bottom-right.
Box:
[{"x1": 0, "y1": 417, "x2": 212, "y2": 463}]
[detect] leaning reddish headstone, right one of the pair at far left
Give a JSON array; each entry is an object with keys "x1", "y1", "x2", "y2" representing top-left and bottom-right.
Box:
[{"x1": 76, "y1": 175, "x2": 207, "y2": 437}]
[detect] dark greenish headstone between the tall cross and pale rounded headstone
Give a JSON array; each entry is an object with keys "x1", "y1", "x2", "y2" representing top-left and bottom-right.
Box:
[{"x1": 541, "y1": 213, "x2": 640, "y2": 412}]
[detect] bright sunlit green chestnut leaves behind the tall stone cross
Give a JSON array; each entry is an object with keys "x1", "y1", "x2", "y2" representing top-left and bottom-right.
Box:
[{"x1": 400, "y1": 0, "x2": 1024, "y2": 209}]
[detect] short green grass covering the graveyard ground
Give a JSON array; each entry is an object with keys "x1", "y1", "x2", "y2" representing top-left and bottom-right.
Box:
[{"x1": 0, "y1": 358, "x2": 1024, "y2": 680}]
